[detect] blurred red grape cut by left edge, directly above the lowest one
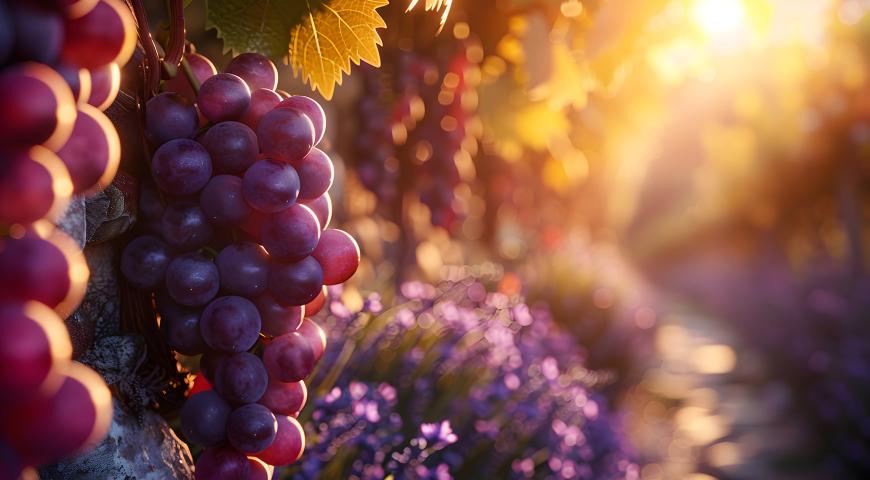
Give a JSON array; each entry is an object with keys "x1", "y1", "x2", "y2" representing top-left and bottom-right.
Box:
[{"x1": 0, "y1": 302, "x2": 72, "y2": 403}]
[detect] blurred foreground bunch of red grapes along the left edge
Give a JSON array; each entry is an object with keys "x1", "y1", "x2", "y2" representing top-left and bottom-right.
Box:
[{"x1": 0, "y1": 0, "x2": 136, "y2": 478}]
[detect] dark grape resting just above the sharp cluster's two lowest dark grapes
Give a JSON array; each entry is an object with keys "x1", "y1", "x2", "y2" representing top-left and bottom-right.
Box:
[{"x1": 214, "y1": 352, "x2": 269, "y2": 404}]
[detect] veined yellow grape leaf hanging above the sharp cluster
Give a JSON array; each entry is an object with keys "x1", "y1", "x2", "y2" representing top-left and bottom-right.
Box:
[{"x1": 289, "y1": 0, "x2": 388, "y2": 100}]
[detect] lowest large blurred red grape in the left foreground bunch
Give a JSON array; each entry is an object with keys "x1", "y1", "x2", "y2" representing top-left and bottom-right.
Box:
[{"x1": 0, "y1": 362, "x2": 112, "y2": 465}]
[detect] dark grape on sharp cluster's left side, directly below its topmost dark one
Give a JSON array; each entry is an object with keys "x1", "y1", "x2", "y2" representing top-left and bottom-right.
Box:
[{"x1": 151, "y1": 138, "x2": 212, "y2": 196}]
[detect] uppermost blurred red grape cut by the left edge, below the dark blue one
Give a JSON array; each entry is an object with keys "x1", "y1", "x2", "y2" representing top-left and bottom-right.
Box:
[{"x1": 0, "y1": 62, "x2": 76, "y2": 150}]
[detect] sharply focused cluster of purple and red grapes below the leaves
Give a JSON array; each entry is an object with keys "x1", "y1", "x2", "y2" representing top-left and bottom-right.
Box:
[{"x1": 121, "y1": 53, "x2": 360, "y2": 479}]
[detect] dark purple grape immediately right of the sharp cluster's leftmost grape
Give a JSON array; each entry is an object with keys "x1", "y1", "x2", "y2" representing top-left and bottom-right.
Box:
[{"x1": 166, "y1": 253, "x2": 221, "y2": 307}]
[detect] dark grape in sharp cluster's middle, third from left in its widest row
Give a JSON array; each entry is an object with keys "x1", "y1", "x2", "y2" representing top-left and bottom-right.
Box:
[{"x1": 215, "y1": 242, "x2": 269, "y2": 298}]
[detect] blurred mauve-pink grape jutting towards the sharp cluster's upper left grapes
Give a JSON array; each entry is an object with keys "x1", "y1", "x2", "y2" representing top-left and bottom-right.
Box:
[{"x1": 57, "y1": 104, "x2": 121, "y2": 193}]
